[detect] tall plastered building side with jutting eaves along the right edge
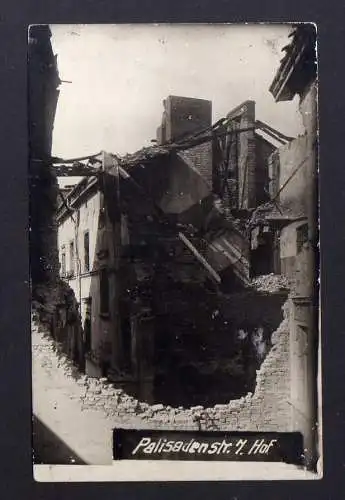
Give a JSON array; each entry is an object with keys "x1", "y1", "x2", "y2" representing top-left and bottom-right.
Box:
[{"x1": 270, "y1": 24, "x2": 321, "y2": 468}]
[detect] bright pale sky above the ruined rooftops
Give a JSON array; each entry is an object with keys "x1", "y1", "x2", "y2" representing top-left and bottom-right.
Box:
[{"x1": 51, "y1": 24, "x2": 302, "y2": 158}]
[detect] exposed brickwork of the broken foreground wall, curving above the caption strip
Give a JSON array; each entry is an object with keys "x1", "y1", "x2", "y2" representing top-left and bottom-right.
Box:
[{"x1": 33, "y1": 300, "x2": 291, "y2": 431}]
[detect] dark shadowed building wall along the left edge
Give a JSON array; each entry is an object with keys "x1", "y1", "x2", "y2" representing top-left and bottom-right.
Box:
[{"x1": 28, "y1": 25, "x2": 87, "y2": 376}]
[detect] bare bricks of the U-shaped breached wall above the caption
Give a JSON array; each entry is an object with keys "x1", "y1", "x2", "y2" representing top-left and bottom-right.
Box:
[{"x1": 33, "y1": 292, "x2": 310, "y2": 460}]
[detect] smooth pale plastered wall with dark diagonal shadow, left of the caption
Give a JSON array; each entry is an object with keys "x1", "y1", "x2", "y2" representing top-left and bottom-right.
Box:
[{"x1": 32, "y1": 328, "x2": 114, "y2": 464}]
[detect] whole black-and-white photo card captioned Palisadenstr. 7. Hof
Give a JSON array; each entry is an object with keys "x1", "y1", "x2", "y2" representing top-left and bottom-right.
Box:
[{"x1": 28, "y1": 23, "x2": 322, "y2": 481}]
